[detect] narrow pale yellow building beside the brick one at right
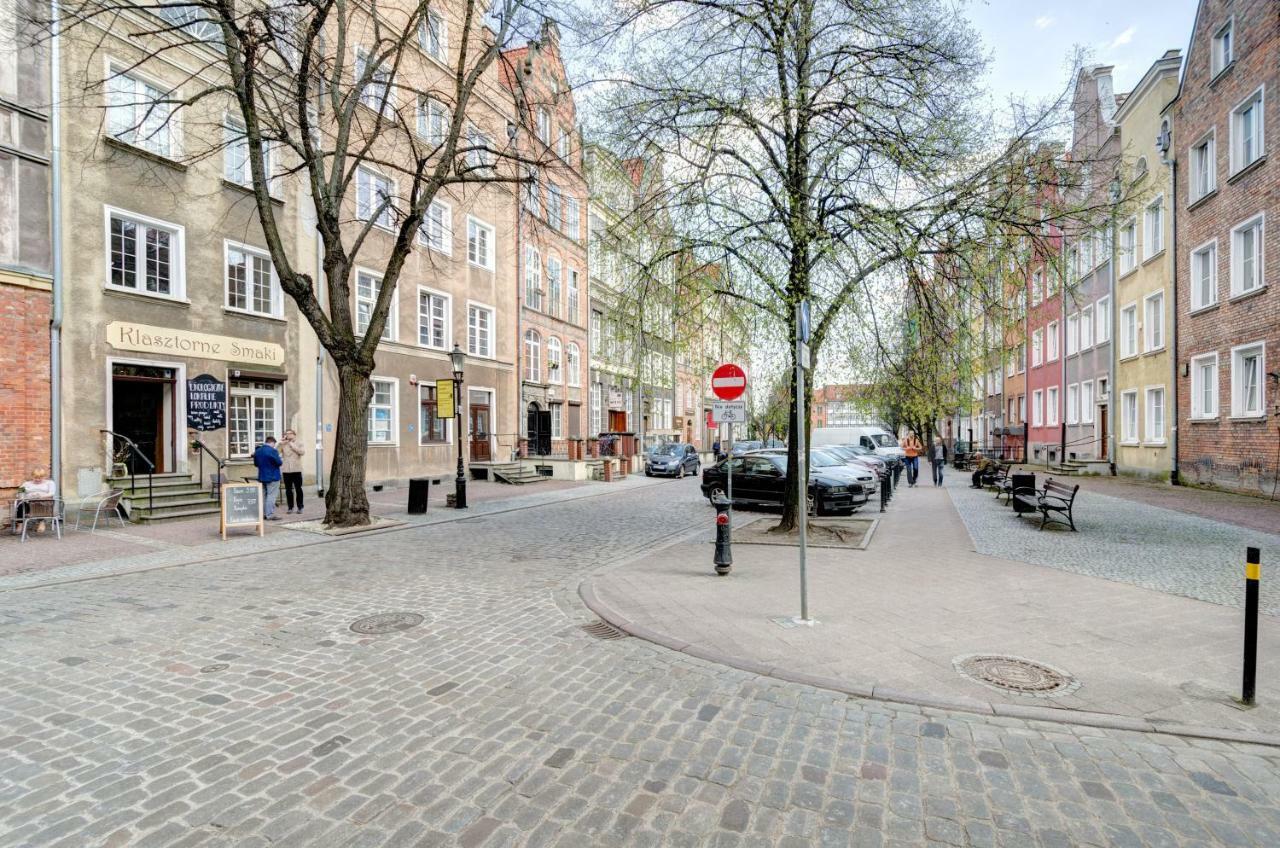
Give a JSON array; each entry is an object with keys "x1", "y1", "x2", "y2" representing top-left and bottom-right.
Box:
[{"x1": 1112, "y1": 50, "x2": 1181, "y2": 479}]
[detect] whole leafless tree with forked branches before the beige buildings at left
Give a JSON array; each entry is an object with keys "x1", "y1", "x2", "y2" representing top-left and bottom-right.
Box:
[{"x1": 51, "y1": 0, "x2": 565, "y2": 526}]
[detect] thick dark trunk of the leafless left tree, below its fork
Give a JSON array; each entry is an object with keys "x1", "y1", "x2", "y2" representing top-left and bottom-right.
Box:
[{"x1": 324, "y1": 365, "x2": 374, "y2": 526}]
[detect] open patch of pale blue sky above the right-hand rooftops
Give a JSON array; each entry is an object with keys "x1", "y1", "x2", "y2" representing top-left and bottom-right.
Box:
[{"x1": 963, "y1": 0, "x2": 1196, "y2": 102}]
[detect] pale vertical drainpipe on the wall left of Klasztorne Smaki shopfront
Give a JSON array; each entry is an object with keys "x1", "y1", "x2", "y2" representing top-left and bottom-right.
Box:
[{"x1": 49, "y1": 0, "x2": 65, "y2": 496}]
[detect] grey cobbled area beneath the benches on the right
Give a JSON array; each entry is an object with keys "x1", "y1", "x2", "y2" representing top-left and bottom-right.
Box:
[{"x1": 947, "y1": 475, "x2": 1280, "y2": 615}]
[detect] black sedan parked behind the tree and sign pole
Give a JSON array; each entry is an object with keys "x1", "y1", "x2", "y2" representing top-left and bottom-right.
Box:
[{"x1": 703, "y1": 453, "x2": 868, "y2": 515}]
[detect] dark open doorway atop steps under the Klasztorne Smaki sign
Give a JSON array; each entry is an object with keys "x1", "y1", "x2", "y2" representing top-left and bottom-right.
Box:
[{"x1": 111, "y1": 363, "x2": 178, "y2": 474}]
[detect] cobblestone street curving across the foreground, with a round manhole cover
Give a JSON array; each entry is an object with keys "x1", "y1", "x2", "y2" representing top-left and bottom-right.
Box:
[{"x1": 0, "y1": 480, "x2": 1280, "y2": 848}]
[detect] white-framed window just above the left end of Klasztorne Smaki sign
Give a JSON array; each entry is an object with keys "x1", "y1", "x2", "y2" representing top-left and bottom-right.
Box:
[{"x1": 106, "y1": 209, "x2": 184, "y2": 300}]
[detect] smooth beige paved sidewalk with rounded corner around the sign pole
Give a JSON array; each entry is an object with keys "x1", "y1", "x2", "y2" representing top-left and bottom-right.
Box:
[{"x1": 588, "y1": 487, "x2": 1280, "y2": 734}]
